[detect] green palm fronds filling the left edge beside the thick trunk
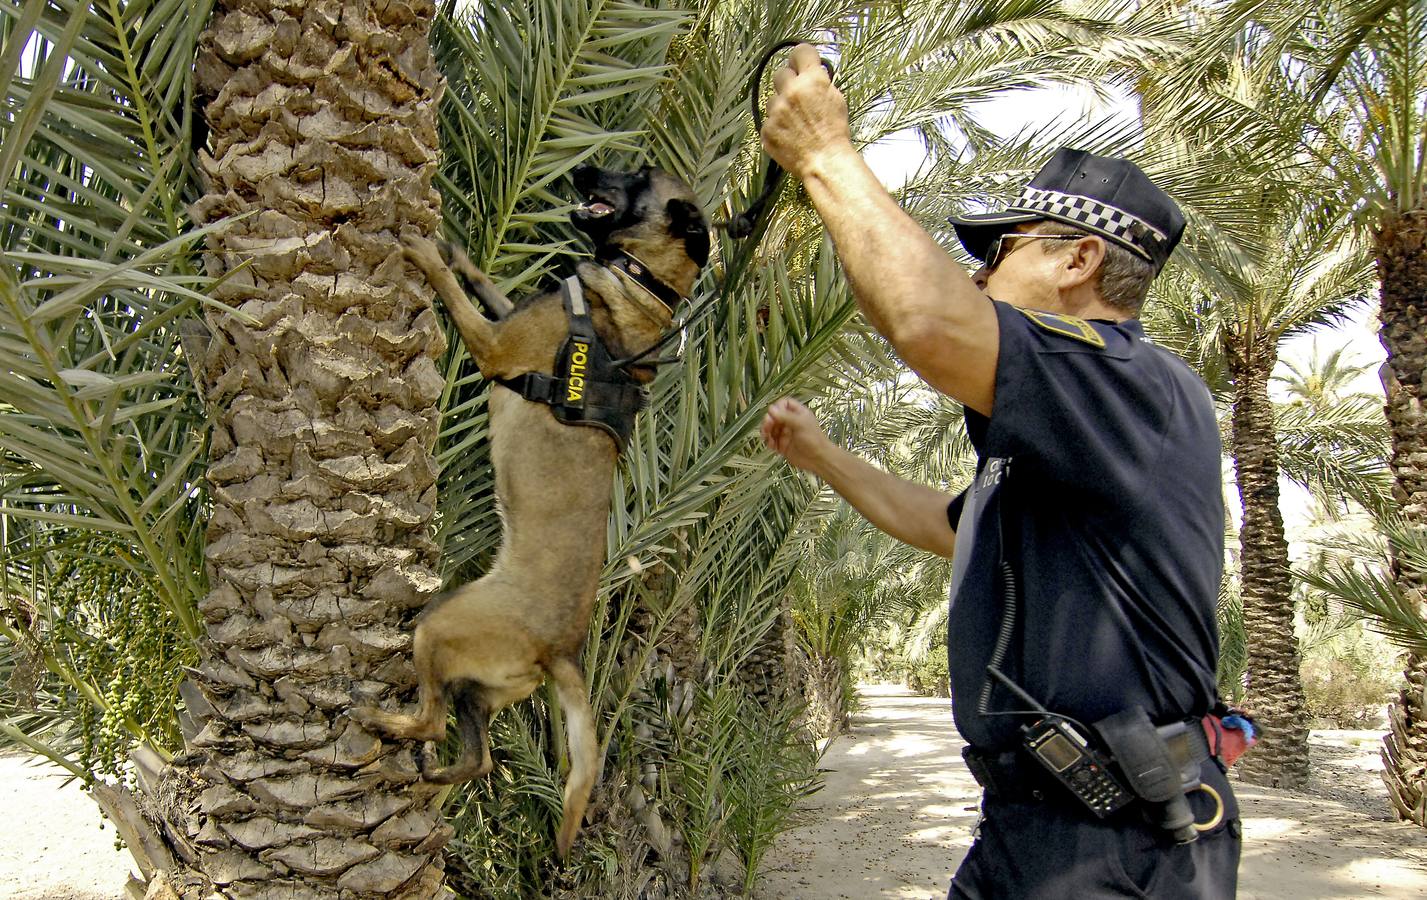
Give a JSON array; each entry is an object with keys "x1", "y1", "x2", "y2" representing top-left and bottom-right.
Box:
[{"x1": 0, "y1": 0, "x2": 213, "y2": 772}]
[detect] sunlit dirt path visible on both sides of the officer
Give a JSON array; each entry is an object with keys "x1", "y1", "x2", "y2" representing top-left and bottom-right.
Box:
[{"x1": 758, "y1": 685, "x2": 1427, "y2": 900}]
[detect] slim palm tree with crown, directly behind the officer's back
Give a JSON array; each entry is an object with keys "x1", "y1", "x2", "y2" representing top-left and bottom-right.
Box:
[{"x1": 1130, "y1": 151, "x2": 1371, "y2": 786}]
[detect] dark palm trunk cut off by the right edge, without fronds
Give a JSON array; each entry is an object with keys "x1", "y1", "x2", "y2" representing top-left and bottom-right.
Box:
[{"x1": 1377, "y1": 208, "x2": 1427, "y2": 827}]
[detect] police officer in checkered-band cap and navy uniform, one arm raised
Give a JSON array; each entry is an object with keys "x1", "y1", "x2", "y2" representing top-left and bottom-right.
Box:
[{"x1": 762, "y1": 44, "x2": 1240, "y2": 900}]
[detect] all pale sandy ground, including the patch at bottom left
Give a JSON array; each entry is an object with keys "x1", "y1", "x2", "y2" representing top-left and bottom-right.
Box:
[{"x1": 0, "y1": 685, "x2": 1427, "y2": 900}]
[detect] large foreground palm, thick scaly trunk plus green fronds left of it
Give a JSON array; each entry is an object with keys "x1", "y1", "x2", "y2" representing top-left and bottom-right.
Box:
[{"x1": 0, "y1": 0, "x2": 450, "y2": 897}]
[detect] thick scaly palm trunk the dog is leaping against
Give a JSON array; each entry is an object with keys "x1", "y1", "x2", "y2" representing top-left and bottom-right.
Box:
[{"x1": 86, "y1": 0, "x2": 450, "y2": 899}]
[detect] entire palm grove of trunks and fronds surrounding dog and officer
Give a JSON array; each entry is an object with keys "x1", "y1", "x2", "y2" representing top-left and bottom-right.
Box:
[{"x1": 0, "y1": 0, "x2": 1427, "y2": 899}]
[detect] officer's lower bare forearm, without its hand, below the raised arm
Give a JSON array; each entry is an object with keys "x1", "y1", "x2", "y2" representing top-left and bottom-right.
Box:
[{"x1": 813, "y1": 444, "x2": 956, "y2": 558}]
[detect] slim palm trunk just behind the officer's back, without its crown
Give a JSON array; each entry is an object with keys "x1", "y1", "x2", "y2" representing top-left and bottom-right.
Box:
[{"x1": 1230, "y1": 339, "x2": 1309, "y2": 787}]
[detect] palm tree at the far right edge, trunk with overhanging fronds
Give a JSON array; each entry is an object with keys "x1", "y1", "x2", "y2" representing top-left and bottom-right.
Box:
[{"x1": 1164, "y1": 0, "x2": 1427, "y2": 826}]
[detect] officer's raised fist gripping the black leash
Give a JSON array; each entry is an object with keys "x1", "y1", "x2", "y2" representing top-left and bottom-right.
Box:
[{"x1": 761, "y1": 44, "x2": 856, "y2": 180}]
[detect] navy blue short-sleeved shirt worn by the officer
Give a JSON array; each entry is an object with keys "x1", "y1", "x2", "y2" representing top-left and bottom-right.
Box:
[{"x1": 946, "y1": 301, "x2": 1224, "y2": 750}]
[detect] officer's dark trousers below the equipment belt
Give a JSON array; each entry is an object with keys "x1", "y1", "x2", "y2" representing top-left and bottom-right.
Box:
[{"x1": 948, "y1": 766, "x2": 1241, "y2": 900}]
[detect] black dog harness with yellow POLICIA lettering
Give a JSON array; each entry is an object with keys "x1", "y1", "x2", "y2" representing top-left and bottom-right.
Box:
[{"x1": 495, "y1": 276, "x2": 647, "y2": 451}]
